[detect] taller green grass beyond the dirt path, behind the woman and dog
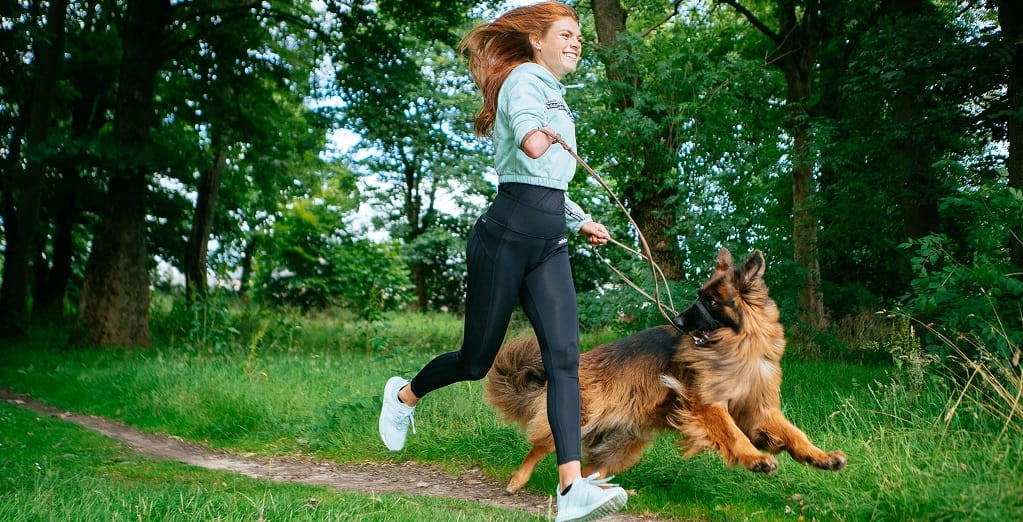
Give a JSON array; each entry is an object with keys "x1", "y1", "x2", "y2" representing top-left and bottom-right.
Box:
[{"x1": 0, "y1": 303, "x2": 1023, "y2": 520}]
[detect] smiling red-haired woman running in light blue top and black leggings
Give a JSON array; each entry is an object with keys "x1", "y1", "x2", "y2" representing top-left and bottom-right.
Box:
[{"x1": 380, "y1": 2, "x2": 628, "y2": 521}]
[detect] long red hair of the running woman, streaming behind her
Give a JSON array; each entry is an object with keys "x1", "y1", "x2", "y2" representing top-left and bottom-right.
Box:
[{"x1": 458, "y1": 2, "x2": 579, "y2": 137}]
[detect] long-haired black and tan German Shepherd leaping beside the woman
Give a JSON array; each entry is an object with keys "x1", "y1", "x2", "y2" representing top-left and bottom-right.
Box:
[{"x1": 484, "y1": 249, "x2": 846, "y2": 492}]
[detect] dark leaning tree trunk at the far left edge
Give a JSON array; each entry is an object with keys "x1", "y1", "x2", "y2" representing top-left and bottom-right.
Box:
[{"x1": 0, "y1": 0, "x2": 68, "y2": 336}]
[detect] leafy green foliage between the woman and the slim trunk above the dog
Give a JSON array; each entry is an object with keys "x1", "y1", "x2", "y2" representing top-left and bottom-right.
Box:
[{"x1": 567, "y1": 3, "x2": 791, "y2": 290}]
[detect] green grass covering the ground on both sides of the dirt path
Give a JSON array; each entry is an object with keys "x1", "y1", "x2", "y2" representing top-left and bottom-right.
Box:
[{"x1": 0, "y1": 302, "x2": 1023, "y2": 520}]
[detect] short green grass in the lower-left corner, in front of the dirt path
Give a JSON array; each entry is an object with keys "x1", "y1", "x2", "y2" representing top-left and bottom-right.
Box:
[{"x1": 0, "y1": 403, "x2": 536, "y2": 521}]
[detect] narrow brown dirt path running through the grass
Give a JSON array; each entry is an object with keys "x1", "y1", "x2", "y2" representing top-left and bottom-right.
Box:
[{"x1": 0, "y1": 388, "x2": 659, "y2": 522}]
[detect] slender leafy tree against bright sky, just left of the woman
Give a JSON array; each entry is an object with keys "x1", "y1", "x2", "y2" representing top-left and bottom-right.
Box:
[{"x1": 335, "y1": 1, "x2": 483, "y2": 310}]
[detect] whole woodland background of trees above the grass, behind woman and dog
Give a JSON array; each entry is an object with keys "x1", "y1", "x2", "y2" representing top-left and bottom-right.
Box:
[{"x1": 0, "y1": 0, "x2": 1023, "y2": 365}]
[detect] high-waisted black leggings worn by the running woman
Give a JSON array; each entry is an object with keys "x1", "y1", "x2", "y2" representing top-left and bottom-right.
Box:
[{"x1": 411, "y1": 183, "x2": 581, "y2": 465}]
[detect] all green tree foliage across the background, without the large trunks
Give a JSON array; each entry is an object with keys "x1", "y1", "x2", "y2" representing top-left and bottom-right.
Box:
[{"x1": 0, "y1": 0, "x2": 1021, "y2": 372}]
